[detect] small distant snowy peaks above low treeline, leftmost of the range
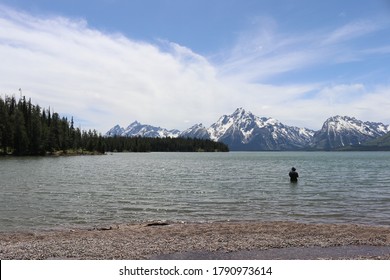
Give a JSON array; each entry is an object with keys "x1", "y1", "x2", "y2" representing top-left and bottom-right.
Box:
[{"x1": 105, "y1": 121, "x2": 180, "y2": 137}]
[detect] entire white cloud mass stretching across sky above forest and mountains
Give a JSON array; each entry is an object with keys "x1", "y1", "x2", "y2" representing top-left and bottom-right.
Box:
[{"x1": 0, "y1": 6, "x2": 390, "y2": 133}]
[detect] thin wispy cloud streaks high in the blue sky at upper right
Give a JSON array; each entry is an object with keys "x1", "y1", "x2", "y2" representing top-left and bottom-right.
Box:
[{"x1": 221, "y1": 18, "x2": 389, "y2": 82}]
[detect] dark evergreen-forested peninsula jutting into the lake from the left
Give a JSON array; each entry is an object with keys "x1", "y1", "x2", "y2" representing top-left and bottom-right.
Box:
[{"x1": 0, "y1": 96, "x2": 229, "y2": 156}]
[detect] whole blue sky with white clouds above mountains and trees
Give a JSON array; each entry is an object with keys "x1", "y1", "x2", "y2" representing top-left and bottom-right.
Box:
[{"x1": 0, "y1": 0, "x2": 390, "y2": 134}]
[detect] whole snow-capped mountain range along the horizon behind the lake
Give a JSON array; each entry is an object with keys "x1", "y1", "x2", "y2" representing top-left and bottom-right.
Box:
[{"x1": 105, "y1": 108, "x2": 390, "y2": 151}]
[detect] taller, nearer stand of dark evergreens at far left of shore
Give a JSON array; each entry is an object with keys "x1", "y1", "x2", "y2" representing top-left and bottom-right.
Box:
[{"x1": 0, "y1": 96, "x2": 104, "y2": 155}]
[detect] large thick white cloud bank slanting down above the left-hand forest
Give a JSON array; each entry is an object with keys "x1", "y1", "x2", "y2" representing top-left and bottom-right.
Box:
[{"x1": 0, "y1": 5, "x2": 230, "y2": 130}]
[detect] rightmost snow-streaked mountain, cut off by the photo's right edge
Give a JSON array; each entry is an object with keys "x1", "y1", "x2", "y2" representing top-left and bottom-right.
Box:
[{"x1": 311, "y1": 116, "x2": 390, "y2": 150}]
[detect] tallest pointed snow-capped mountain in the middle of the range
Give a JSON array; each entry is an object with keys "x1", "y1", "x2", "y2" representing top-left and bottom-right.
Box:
[{"x1": 203, "y1": 108, "x2": 314, "y2": 150}]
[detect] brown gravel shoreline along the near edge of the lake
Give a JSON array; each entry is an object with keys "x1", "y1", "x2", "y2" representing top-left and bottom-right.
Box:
[{"x1": 0, "y1": 222, "x2": 390, "y2": 260}]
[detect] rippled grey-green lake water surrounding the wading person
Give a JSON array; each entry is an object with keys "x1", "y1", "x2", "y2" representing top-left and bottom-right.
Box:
[{"x1": 0, "y1": 152, "x2": 390, "y2": 232}]
